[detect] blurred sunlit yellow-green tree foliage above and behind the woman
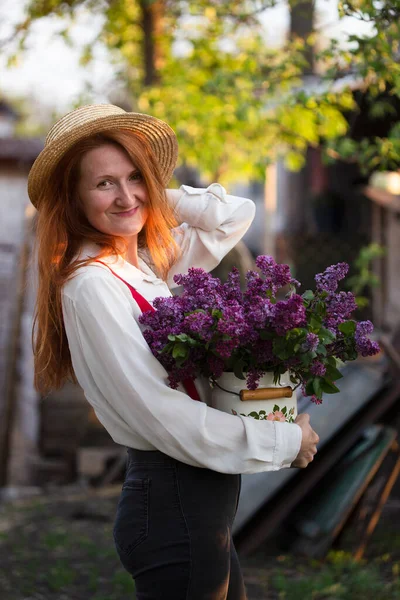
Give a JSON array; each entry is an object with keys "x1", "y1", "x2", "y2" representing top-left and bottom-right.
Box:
[{"x1": 3, "y1": 0, "x2": 400, "y2": 183}]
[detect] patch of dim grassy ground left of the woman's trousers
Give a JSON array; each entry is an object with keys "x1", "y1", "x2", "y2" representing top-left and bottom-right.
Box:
[{"x1": 0, "y1": 486, "x2": 135, "y2": 600}]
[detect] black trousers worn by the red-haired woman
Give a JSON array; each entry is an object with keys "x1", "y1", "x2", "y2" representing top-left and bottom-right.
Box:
[{"x1": 114, "y1": 448, "x2": 246, "y2": 600}]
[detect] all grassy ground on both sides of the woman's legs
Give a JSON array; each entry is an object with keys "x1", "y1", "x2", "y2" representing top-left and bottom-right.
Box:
[{"x1": 0, "y1": 486, "x2": 400, "y2": 600}]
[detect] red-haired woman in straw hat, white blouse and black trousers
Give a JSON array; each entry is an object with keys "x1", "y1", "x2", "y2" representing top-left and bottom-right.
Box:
[{"x1": 28, "y1": 105, "x2": 318, "y2": 600}]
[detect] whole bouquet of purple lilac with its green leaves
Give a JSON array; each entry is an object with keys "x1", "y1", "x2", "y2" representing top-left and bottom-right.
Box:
[{"x1": 140, "y1": 255, "x2": 379, "y2": 404}]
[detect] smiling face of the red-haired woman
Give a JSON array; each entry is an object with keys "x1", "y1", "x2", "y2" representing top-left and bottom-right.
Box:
[{"x1": 78, "y1": 144, "x2": 147, "y2": 238}]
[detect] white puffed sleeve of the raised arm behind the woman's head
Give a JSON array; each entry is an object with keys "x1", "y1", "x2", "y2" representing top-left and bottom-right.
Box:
[{"x1": 166, "y1": 183, "x2": 255, "y2": 288}]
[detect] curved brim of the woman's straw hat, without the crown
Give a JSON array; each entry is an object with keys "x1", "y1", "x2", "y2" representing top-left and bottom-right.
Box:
[{"x1": 28, "y1": 112, "x2": 178, "y2": 207}]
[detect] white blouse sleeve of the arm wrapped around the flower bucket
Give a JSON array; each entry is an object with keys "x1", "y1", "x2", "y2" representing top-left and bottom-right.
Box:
[{"x1": 63, "y1": 274, "x2": 301, "y2": 473}]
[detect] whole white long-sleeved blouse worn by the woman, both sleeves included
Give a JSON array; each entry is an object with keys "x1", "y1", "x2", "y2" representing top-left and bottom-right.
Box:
[{"x1": 62, "y1": 184, "x2": 302, "y2": 473}]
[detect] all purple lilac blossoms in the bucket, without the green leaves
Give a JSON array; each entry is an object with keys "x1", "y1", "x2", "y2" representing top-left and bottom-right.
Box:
[{"x1": 139, "y1": 256, "x2": 379, "y2": 404}]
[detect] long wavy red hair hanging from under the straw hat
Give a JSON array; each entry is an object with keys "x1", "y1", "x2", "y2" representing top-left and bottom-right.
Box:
[{"x1": 32, "y1": 130, "x2": 180, "y2": 395}]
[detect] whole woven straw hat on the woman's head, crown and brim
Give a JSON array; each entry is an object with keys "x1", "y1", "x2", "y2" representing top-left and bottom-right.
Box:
[{"x1": 28, "y1": 104, "x2": 178, "y2": 207}]
